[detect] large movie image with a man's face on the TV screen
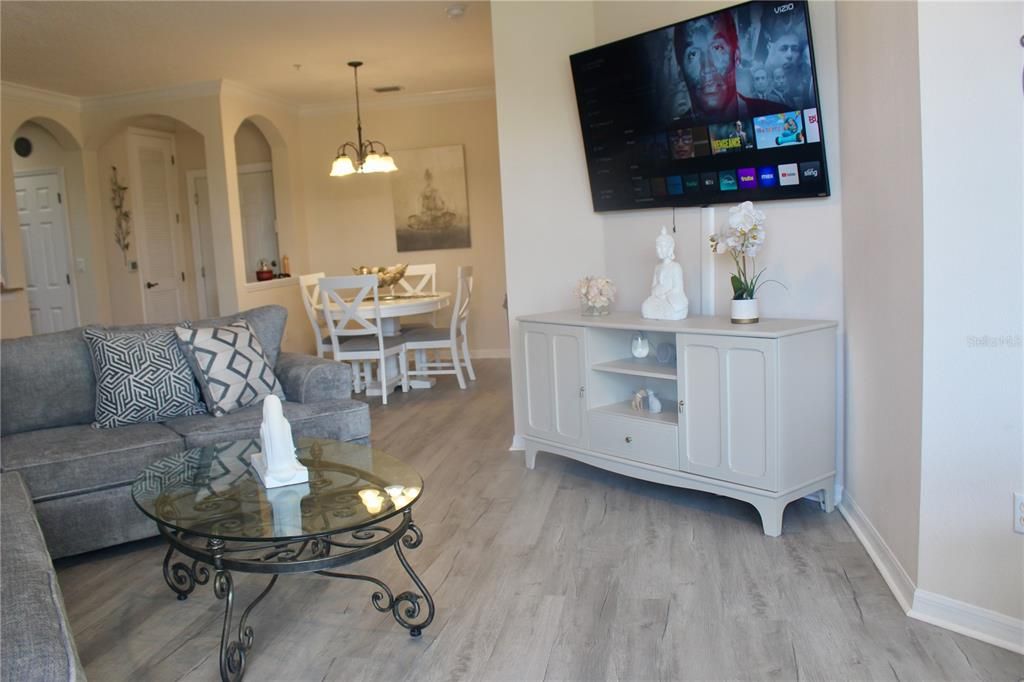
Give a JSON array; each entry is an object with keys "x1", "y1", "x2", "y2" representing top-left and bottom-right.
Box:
[{"x1": 645, "y1": 2, "x2": 816, "y2": 125}]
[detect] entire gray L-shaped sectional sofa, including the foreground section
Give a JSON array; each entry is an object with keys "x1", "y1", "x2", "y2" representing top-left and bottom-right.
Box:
[{"x1": 0, "y1": 305, "x2": 370, "y2": 682}]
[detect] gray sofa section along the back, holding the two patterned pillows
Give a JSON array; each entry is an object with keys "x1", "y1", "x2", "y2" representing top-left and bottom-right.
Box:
[{"x1": 0, "y1": 305, "x2": 370, "y2": 558}]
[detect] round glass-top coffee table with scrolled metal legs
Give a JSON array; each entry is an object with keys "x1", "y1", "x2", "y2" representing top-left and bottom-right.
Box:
[{"x1": 132, "y1": 438, "x2": 434, "y2": 680}]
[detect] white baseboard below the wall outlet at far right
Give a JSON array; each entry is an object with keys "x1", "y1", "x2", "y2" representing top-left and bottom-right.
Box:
[{"x1": 907, "y1": 589, "x2": 1024, "y2": 653}]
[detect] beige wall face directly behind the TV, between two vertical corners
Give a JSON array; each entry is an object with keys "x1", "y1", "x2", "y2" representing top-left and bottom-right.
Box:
[{"x1": 589, "y1": 0, "x2": 845, "y2": 487}]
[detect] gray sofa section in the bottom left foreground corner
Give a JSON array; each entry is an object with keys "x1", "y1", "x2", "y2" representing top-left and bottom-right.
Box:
[{"x1": 0, "y1": 473, "x2": 85, "y2": 682}]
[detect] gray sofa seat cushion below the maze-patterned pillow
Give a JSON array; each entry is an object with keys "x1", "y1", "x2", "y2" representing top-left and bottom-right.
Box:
[{"x1": 0, "y1": 424, "x2": 184, "y2": 501}]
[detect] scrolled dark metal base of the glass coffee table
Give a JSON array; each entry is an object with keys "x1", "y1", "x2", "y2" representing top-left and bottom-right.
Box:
[{"x1": 160, "y1": 509, "x2": 435, "y2": 682}]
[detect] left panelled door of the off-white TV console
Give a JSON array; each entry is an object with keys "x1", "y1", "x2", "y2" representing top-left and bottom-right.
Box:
[{"x1": 522, "y1": 323, "x2": 585, "y2": 445}]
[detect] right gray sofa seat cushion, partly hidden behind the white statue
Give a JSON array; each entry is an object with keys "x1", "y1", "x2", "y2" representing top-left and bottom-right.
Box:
[{"x1": 167, "y1": 399, "x2": 370, "y2": 447}]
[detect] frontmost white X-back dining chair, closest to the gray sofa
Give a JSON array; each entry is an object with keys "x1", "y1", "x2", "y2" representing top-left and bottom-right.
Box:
[{"x1": 319, "y1": 274, "x2": 409, "y2": 404}]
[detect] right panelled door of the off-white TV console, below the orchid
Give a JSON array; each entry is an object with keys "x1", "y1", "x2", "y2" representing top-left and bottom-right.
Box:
[{"x1": 677, "y1": 334, "x2": 778, "y2": 491}]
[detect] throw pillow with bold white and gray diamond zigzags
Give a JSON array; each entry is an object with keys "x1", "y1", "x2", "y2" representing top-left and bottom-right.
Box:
[{"x1": 174, "y1": 319, "x2": 285, "y2": 417}]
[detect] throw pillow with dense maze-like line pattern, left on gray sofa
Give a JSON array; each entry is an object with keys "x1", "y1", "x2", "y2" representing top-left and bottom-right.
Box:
[{"x1": 82, "y1": 327, "x2": 206, "y2": 429}]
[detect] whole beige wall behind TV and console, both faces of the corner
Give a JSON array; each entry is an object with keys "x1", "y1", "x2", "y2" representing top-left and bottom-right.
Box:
[{"x1": 492, "y1": 1, "x2": 844, "y2": 478}]
